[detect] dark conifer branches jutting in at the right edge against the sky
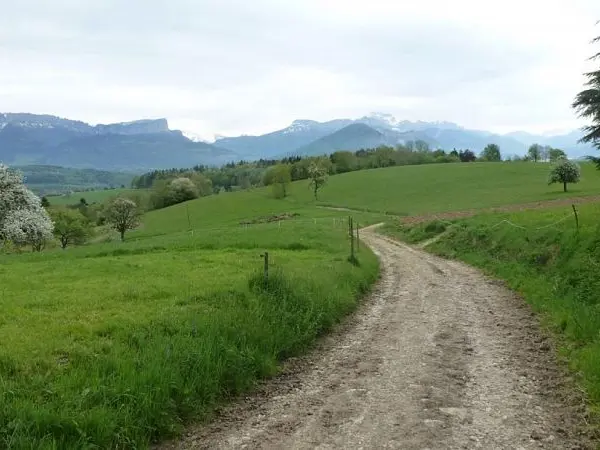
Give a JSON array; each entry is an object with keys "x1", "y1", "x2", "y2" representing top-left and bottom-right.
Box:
[{"x1": 573, "y1": 36, "x2": 600, "y2": 156}]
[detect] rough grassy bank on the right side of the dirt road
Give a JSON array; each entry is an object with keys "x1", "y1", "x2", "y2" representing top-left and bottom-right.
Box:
[{"x1": 388, "y1": 203, "x2": 600, "y2": 418}]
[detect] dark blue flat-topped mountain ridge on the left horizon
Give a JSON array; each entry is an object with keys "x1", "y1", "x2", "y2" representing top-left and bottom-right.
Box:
[{"x1": 0, "y1": 113, "x2": 237, "y2": 172}]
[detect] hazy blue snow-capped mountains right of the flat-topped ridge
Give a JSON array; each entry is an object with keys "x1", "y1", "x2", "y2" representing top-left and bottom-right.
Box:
[{"x1": 215, "y1": 112, "x2": 593, "y2": 159}]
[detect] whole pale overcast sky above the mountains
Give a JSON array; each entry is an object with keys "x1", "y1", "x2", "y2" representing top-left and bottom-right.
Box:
[{"x1": 0, "y1": 0, "x2": 600, "y2": 137}]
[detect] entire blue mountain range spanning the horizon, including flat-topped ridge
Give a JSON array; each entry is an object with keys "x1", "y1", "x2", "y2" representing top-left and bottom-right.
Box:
[{"x1": 0, "y1": 113, "x2": 594, "y2": 172}]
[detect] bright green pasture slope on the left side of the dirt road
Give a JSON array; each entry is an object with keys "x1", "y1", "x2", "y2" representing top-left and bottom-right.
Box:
[{"x1": 0, "y1": 186, "x2": 378, "y2": 449}]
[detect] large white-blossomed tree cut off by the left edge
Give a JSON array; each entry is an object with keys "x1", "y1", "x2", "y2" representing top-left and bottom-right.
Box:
[{"x1": 0, "y1": 164, "x2": 53, "y2": 251}]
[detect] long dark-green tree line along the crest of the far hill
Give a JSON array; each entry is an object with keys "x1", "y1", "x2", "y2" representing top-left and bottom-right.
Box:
[{"x1": 125, "y1": 141, "x2": 566, "y2": 209}]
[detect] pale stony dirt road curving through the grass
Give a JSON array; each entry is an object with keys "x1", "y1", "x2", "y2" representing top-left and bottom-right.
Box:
[{"x1": 164, "y1": 225, "x2": 589, "y2": 450}]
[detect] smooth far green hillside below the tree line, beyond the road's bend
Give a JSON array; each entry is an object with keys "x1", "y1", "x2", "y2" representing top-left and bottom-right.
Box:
[{"x1": 319, "y1": 163, "x2": 600, "y2": 215}]
